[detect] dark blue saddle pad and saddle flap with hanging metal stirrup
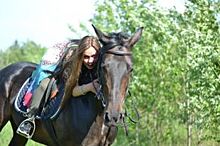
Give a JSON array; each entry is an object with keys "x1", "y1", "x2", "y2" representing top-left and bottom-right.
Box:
[{"x1": 14, "y1": 78, "x2": 64, "y2": 138}]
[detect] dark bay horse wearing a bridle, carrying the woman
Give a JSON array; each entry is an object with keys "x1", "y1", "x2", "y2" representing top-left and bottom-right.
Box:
[{"x1": 0, "y1": 26, "x2": 143, "y2": 146}]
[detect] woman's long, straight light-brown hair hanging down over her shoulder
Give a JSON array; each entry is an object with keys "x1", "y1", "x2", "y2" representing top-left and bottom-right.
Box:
[{"x1": 61, "y1": 36, "x2": 101, "y2": 108}]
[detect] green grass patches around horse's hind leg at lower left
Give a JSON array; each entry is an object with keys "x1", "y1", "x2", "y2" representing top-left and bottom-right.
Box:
[{"x1": 0, "y1": 123, "x2": 43, "y2": 146}]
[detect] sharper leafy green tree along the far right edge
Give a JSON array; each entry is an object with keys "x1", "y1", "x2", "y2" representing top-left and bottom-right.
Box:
[{"x1": 181, "y1": 0, "x2": 220, "y2": 141}]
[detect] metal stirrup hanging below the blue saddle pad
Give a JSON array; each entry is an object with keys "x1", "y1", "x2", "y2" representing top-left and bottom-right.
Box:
[{"x1": 16, "y1": 117, "x2": 36, "y2": 139}]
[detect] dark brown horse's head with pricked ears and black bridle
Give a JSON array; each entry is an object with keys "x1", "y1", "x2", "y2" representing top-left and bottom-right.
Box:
[{"x1": 93, "y1": 26, "x2": 143, "y2": 125}]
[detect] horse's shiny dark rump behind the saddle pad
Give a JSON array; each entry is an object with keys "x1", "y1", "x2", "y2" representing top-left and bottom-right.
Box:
[{"x1": 0, "y1": 62, "x2": 36, "y2": 131}]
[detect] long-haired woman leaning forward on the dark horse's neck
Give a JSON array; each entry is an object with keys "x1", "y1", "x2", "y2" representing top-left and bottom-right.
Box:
[{"x1": 17, "y1": 36, "x2": 100, "y2": 138}]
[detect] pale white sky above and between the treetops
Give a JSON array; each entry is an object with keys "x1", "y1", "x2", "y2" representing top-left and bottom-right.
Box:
[{"x1": 0, "y1": 0, "x2": 184, "y2": 50}]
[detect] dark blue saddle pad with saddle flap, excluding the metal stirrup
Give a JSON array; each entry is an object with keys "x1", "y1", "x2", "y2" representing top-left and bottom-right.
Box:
[{"x1": 14, "y1": 77, "x2": 64, "y2": 120}]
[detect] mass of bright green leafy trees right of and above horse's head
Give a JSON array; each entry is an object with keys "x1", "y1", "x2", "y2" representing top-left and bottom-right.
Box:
[{"x1": 93, "y1": 0, "x2": 220, "y2": 145}]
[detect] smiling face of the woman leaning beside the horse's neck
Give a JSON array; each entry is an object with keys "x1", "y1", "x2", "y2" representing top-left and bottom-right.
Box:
[{"x1": 83, "y1": 47, "x2": 98, "y2": 69}]
